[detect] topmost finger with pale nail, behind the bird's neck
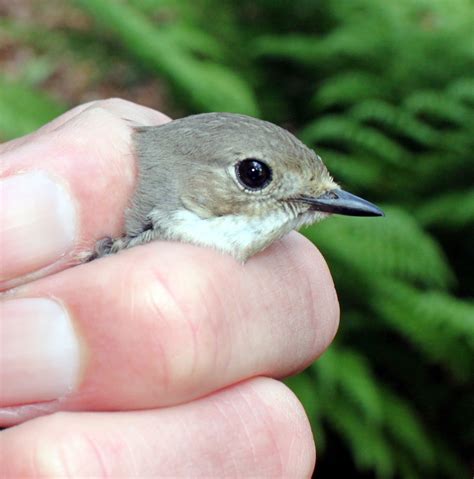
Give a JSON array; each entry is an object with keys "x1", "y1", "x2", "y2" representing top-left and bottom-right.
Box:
[{"x1": 0, "y1": 100, "x2": 167, "y2": 289}]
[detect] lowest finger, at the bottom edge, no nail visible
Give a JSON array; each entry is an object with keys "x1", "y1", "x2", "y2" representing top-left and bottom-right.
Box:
[{"x1": 0, "y1": 378, "x2": 315, "y2": 478}]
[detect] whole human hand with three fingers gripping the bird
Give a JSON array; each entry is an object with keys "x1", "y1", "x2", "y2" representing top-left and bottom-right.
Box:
[{"x1": 0, "y1": 100, "x2": 339, "y2": 478}]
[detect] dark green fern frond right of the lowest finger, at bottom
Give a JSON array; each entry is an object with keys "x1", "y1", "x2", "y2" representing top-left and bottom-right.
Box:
[{"x1": 290, "y1": 345, "x2": 448, "y2": 478}]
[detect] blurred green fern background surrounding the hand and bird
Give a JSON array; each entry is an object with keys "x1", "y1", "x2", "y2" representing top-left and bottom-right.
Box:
[{"x1": 0, "y1": 0, "x2": 474, "y2": 478}]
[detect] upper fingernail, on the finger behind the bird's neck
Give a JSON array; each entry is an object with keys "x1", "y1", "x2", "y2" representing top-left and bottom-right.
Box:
[{"x1": 0, "y1": 171, "x2": 76, "y2": 280}]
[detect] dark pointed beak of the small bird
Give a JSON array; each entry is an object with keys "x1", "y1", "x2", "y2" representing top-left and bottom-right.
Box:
[{"x1": 299, "y1": 190, "x2": 384, "y2": 216}]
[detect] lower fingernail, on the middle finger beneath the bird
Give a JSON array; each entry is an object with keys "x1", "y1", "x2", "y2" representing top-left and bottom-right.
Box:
[{"x1": 0, "y1": 298, "x2": 80, "y2": 407}]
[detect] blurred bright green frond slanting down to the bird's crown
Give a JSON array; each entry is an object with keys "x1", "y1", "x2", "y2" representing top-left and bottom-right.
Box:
[{"x1": 78, "y1": 0, "x2": 258, "y2": 115}]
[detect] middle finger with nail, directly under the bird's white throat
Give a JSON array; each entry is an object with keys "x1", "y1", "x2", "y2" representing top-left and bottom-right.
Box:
[{"x1": 0, "y1": 233, "x2": 339, "y2": 424}]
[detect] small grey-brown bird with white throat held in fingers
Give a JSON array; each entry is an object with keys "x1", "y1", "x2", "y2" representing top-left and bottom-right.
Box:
[{"x1": 87, "y1": 113, "x2": 383, "y2": 262}]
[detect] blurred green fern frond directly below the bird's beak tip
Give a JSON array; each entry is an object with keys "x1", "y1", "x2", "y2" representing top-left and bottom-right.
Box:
[{"x1": 303, "y1": 207, "x2": 453, "y2": 288}]
